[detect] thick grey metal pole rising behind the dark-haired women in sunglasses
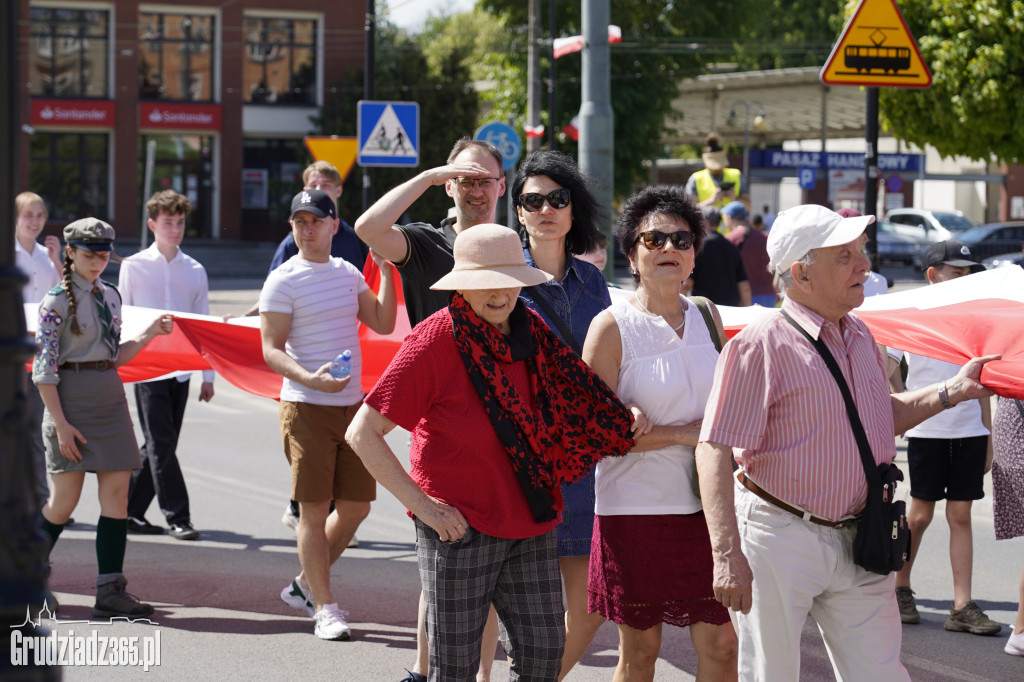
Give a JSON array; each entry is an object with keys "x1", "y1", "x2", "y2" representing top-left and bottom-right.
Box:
[{"x1": 580, "y1": 0, "x2": 614, "y2": 281}]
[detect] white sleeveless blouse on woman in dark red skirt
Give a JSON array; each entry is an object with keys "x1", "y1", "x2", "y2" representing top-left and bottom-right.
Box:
[{"x1": 595, "y1": 300, "x2": 718, "y2": 516}]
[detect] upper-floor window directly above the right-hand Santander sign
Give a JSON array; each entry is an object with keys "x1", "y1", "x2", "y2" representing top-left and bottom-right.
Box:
[{"x1": 138, "y1": 12, "x2": 214, "y2": 101}]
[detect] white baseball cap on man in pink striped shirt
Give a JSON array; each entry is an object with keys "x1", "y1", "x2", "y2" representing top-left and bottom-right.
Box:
[{"x1": 768, "y1": 204, "x2": 874, "y2": 273}]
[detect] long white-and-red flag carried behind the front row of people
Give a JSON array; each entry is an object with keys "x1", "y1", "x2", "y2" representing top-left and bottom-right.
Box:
[{"x1": 25, "y1": 260, "x2": 1024, "y2": 399}]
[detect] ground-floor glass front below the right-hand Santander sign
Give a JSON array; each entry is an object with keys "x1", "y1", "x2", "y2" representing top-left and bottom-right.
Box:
[{"x1": 138, "y1": 135, "x2": 213, "y2": 239}]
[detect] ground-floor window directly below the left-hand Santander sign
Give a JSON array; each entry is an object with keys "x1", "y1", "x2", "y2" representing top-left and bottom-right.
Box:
[{"x1": 29, "y1": 132, "x2": 111, "y2": 222}]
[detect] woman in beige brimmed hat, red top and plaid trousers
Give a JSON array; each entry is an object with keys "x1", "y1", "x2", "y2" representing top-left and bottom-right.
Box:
[{"x1": 347, "y1": 224, "x2": 633, "y2": 681}]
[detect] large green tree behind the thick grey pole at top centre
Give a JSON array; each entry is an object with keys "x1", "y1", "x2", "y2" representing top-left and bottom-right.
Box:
[{"x1": 480, "y1": 0, "x2": 757, "y2": 196}]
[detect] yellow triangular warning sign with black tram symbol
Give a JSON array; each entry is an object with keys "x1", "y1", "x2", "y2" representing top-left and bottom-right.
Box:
[{"x1": 821, "y1": 0, "x2": 932, "y2": 88}]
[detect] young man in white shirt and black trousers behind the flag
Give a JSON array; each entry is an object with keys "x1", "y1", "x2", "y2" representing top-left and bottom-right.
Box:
[{"x1": 119, "y1": 189, "x2": 214, "y2": 540}]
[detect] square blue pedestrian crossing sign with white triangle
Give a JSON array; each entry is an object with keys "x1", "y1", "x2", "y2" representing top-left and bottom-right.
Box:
[{"x1": 356, "y1": 100, "x2": 420, "y2": 166}]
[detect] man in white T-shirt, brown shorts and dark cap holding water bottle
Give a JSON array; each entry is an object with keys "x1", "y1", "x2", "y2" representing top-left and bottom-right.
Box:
[{"x1": 259, "y1": 189, "x2": 397, "y2": 640}]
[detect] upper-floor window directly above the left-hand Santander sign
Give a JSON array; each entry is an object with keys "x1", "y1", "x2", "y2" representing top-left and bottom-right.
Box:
[{"x1": 29, "y1": 7, "x2": 110, "y2": 97}]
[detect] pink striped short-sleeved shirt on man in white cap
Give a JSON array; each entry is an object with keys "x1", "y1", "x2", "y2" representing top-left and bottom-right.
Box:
[{"x1": 700, "y1": 299, "x2": 896, "y2": 520}]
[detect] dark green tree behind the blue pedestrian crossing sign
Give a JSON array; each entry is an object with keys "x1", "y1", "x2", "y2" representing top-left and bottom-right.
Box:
[{"x1": 313, "y1": 22, "x2": 479, "y2": 224}]
